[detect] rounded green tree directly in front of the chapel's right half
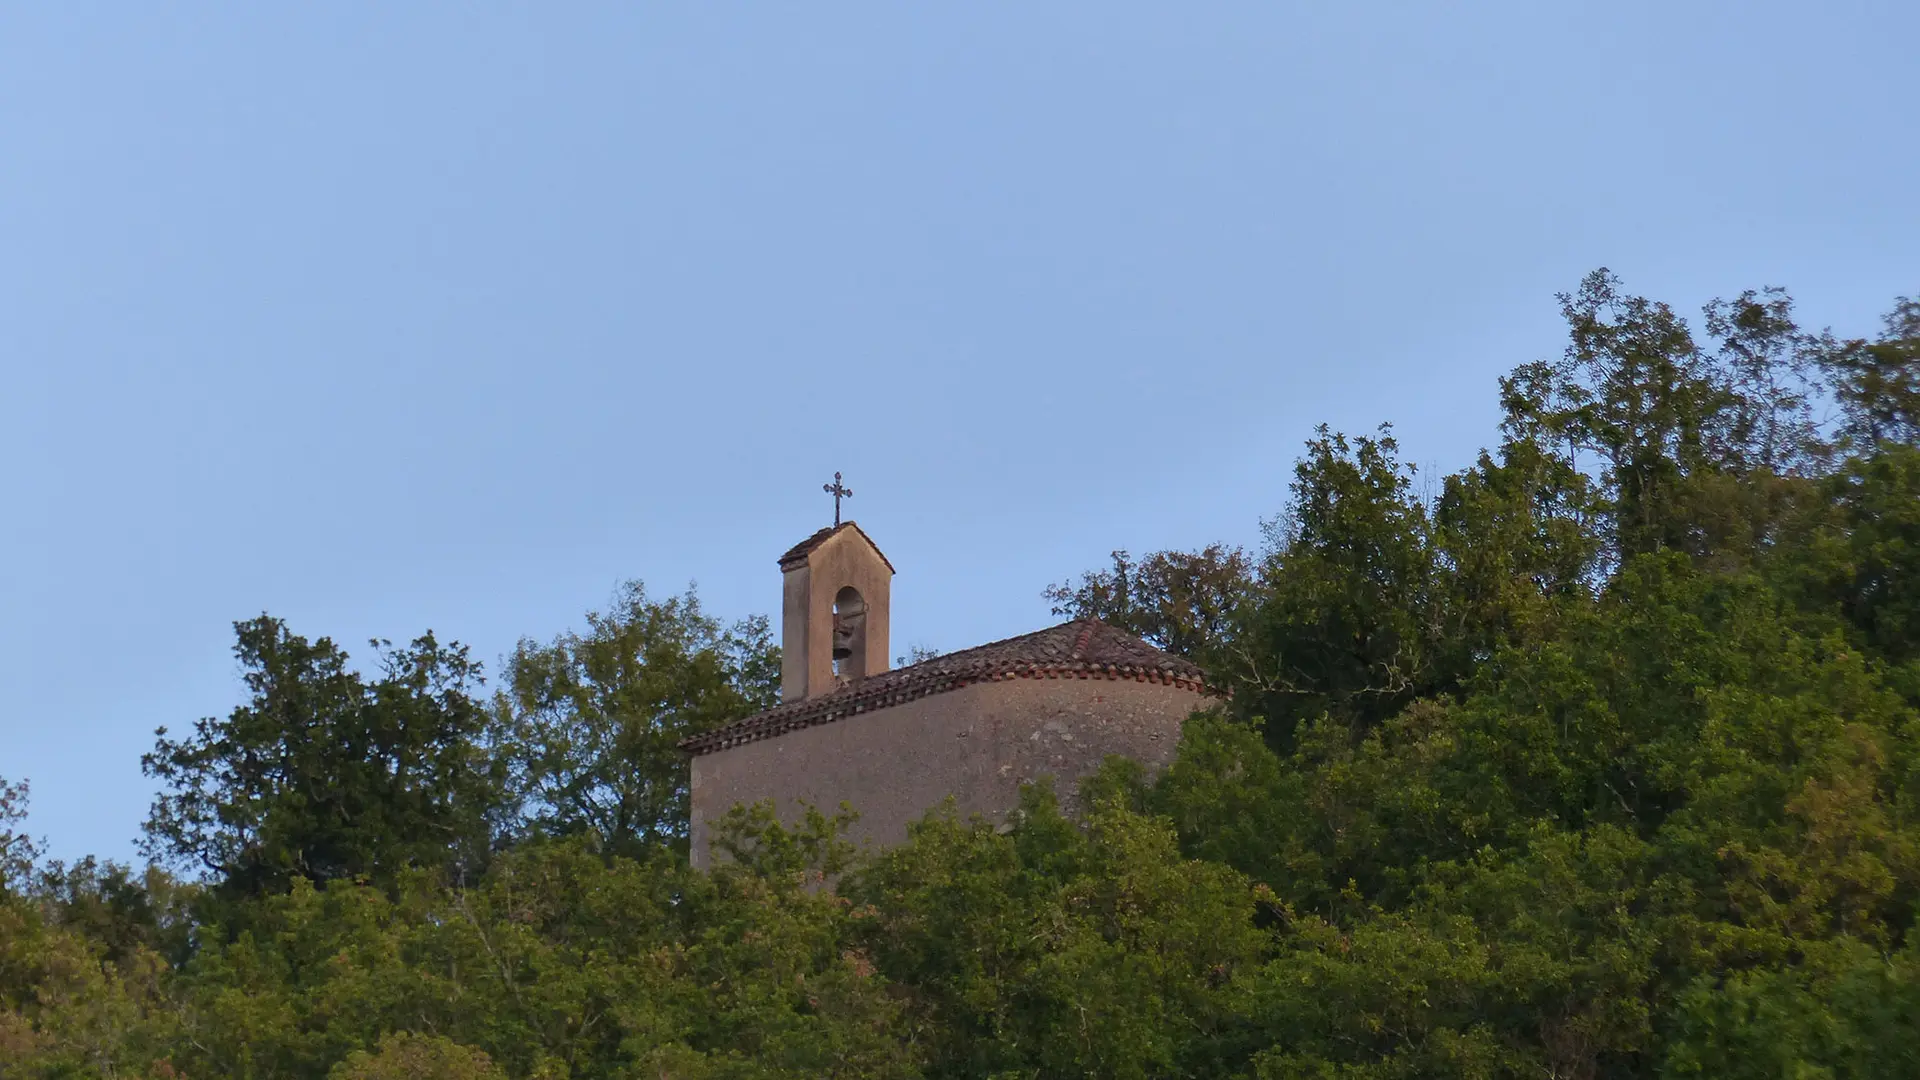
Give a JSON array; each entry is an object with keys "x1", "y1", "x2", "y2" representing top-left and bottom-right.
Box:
[{"x1": 845, "y1": 788, "x2": 1263, "y2": 1078}]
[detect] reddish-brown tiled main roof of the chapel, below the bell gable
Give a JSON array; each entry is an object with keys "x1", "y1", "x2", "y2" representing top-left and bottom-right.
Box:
[{"x1": 680, "y1": 618, "x2": 1208, "y2": 755}]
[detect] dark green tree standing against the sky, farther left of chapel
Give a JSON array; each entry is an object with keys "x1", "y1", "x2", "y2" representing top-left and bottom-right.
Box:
[{"x1": 142, "y1": 615, "x2": 505, "y2": 897}]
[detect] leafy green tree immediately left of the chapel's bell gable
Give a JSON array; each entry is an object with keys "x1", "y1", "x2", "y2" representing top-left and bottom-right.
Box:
[{"x1": 495, "y1": 580, "x2": 780, "y2": 855}]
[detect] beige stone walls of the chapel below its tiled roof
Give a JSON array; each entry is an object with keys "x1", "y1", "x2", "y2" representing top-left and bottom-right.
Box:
[{"x1": 691, "y1": 678, "x2": 1208, "y2": 867}]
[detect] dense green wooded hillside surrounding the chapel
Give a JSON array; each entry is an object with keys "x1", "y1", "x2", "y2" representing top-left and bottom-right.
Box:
[{"x1": 0, "y1": 271, "x2": 1920, "y2": 1080}]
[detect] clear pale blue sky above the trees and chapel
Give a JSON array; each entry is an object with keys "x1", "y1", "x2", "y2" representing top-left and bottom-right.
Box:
[{"x1": 0, "y1": 0, "x2": 1920, "y2": 857}]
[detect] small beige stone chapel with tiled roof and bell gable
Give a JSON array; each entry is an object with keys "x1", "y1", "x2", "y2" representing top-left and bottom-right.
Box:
[{"x1": 680, "y1": 521, "x2": 1208, "y2": 867}]
